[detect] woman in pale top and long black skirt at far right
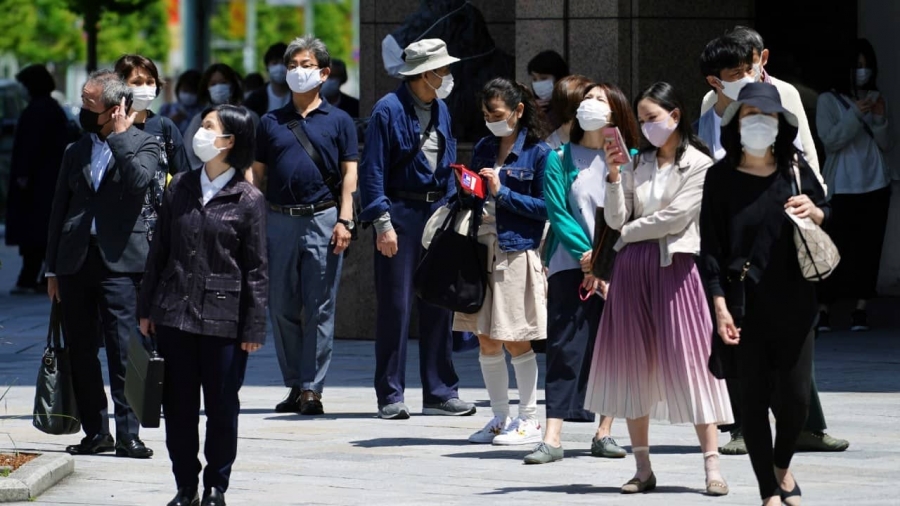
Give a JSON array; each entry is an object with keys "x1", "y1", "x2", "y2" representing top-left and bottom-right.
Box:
[{"x1": 816, "y1": 39, "x2": 891, "y2": 331}]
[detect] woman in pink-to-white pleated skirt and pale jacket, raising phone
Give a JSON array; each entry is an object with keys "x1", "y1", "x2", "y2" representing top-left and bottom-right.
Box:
[{"x1": 585, "y1": 83, "x2": 733, "y2": 495}]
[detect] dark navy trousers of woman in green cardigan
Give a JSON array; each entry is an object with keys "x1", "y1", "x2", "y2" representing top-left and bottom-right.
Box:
[{"x1": 544, "y1": 269, "x2": 603, "y2": 422}]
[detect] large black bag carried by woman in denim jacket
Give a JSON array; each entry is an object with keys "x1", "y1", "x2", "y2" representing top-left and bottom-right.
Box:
[{"x1": 413, "y1": 202, "x2": 488, "y2": 314}]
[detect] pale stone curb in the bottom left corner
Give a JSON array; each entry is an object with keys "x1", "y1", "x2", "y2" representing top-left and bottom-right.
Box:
[{"x1": 0, "y1": 453, "x2": 75, "y2": 502}]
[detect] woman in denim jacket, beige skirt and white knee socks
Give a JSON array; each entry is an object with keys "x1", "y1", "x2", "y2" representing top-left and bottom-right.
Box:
[{"x1": 453, "y1": 78, "x2": 556, "y2": 445}]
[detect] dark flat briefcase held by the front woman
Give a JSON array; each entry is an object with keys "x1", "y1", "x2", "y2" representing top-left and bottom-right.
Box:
[{"x1": 125, "y1": 327, "x2": 165, "y2": 428}]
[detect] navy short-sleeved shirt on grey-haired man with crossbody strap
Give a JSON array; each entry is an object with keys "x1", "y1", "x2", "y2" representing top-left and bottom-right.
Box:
[{"x1": 256, "y1": 100, "x2": 359, "y2": 206}]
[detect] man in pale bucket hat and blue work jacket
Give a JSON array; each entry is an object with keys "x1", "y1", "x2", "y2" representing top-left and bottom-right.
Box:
[{"x1": 359, "y1": 39, "x2": 475, "y2": 419}]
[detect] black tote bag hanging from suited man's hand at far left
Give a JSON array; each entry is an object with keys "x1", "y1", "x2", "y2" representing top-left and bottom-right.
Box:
[{"x1": 31, "y1": 302, "x2": 81, "y2": 436}]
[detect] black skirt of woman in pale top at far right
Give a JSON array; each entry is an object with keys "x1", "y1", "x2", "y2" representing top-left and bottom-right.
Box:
[{"x1": 818, "y1": 187, "x2": 891, "y2": 304}]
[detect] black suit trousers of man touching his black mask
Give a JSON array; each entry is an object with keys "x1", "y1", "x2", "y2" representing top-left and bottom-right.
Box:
[{"x1": 59, "y1": 245, "x2": 141, "y2": 438}]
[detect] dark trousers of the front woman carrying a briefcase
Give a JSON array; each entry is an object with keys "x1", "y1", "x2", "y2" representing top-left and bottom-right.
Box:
[{"x1": 156, "y1": 326, "x2": 247, "y2": 493}]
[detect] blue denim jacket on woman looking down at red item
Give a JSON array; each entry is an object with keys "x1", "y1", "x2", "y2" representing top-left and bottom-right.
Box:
[{"x1": 471, "y1": 128, "x2": 556, "y2": 251}]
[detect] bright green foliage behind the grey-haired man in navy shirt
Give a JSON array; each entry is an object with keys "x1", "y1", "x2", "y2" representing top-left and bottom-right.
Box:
[{"x1": 210, "y1": 0, "x2": 353, "y2": 75}]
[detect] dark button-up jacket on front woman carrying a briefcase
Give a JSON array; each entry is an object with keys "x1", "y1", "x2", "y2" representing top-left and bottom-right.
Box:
[{"x1": 138, "y1": 169, "x2": 269, "y2": 344}]
